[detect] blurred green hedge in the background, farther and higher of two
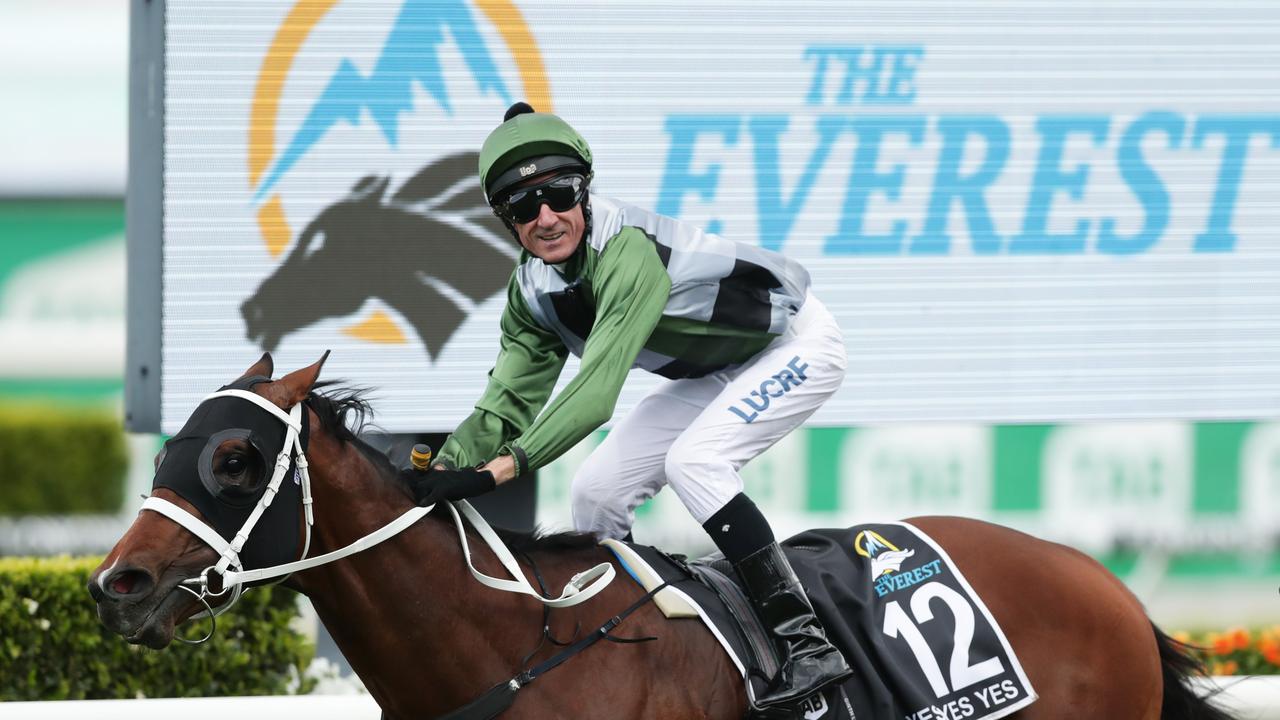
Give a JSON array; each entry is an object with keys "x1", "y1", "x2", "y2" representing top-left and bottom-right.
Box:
[{"x1": 0, "y1": 406, "x2": 129, "y2": 515}]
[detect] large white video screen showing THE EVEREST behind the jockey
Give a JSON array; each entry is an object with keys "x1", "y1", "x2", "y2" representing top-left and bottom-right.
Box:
[{"x1": 160, "y1": 0, "x2": 1280, "y2": 432}]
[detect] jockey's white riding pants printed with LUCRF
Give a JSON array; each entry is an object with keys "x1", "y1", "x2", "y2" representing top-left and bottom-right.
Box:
[{"x1": 572, "y1": 293, "x2": 846, "y2": 538}]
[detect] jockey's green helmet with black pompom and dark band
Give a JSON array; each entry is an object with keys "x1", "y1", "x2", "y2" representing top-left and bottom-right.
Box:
[{"x1": 480, "y1": 102, "x2": 591, "y2": 205}]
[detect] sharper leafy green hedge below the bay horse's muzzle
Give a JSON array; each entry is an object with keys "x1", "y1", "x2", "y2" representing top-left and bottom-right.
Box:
[{"x1": 0, "y1": 557, "x2": 315, "y2": 696}]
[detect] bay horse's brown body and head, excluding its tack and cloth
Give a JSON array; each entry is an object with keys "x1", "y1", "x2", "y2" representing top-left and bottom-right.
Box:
[{"x1": 90, "y1": 354, "x2": 1229, "y2": 720}]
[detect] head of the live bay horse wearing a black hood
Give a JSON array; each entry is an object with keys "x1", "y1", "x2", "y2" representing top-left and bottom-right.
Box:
[{"x1": 88, "y1": 355, "x2": 348, "y2": 648}]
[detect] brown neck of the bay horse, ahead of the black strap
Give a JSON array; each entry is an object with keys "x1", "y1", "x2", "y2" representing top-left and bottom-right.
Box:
[{"x1": 292, "y1": 425, "x2": 541, "y2": 716}]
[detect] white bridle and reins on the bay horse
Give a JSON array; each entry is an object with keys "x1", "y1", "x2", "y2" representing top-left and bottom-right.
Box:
[{"x1": 142, "y1": 389, "x2": 616, "y2": 644}]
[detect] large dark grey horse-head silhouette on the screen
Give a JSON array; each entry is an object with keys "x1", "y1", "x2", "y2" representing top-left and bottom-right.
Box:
[{"x1": 241, "y1": 152, "x2": 520, "y2": 357}]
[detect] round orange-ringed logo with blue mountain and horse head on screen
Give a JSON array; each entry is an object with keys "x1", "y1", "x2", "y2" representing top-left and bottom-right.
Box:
[{"x1": 241, "y1": 0, "x2": 553, "y2": 357}]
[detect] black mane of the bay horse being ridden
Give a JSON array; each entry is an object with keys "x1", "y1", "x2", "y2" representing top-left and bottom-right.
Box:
[{"x1": 307, "y1": 380, "x2": 596, "y2": 553}]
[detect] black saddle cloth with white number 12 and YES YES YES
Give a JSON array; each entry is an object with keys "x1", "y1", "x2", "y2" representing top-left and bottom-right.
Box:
[{"x1": 605, "y1": 523, "x2": 1037, "y2": 720}]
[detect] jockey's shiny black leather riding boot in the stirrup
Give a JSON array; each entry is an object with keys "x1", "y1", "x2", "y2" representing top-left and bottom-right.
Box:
[{"x1": 733, "y1": 542, "x2": 854, "y2": 708}]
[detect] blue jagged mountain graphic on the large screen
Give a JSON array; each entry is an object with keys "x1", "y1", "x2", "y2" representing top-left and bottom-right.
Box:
[{"x1": 253, "y1": 0, "x2": 511, "y2": 202}]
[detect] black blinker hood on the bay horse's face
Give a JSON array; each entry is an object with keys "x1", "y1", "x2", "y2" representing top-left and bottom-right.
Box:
[{"x1": 151, "y1": 375, "x2": 308, "y2": 570}]
